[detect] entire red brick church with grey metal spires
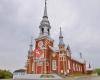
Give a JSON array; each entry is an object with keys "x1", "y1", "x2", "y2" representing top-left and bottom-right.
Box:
[{"x1": 26, "y1": 1, "x2": 86, "y2": 75}]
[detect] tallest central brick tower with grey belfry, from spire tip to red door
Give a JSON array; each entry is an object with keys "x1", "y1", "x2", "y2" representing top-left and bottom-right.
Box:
[{"x1": 34, "y1": 0, "x2": 53, "y2": 74}]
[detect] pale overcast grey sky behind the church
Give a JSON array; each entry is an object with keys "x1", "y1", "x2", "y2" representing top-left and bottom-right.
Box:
[{"x1": 0, "y1": 0, "x2": 100, "y2": 71}]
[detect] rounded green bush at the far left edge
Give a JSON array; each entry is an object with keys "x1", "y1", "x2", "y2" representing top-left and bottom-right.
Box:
[{"x1": 0, "y1": 70, "x2": 13, "y2": 79}]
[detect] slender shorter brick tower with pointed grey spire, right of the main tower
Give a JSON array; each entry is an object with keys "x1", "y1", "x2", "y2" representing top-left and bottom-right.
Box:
[{"x1": 58, "y1": 27, "x2": 67, "y2": 75}]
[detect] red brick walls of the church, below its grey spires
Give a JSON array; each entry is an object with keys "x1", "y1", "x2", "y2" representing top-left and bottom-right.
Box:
[{"x1": 26, "y1": 38, "x2": 86, "y2": 74}]
